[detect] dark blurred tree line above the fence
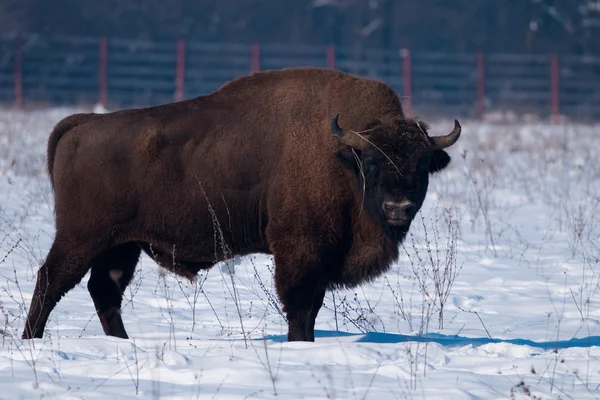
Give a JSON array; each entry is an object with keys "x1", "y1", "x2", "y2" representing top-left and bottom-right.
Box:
[{"x1": 0, "y1": 0, "x2": 600, "y2": 54}]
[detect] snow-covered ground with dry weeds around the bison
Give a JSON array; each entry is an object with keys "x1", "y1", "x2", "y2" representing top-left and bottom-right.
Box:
[{"x1": 0, "y1": 109, "x2": 600, "y2": 400}]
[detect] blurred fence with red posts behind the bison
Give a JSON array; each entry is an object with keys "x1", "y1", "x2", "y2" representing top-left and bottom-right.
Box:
[{"x1": 0, "y1": 35, "x2": 600, "y2": 121}]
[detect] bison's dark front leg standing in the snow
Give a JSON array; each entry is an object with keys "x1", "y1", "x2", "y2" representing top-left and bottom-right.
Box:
[{"x1": 275, "y1": 255, "x2": 325, "y2": 342}]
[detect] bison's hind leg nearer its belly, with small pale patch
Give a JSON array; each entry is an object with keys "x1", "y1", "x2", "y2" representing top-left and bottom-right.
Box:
[{"x1": 88, "y1": 243, "x2": 142, "y2": 339}]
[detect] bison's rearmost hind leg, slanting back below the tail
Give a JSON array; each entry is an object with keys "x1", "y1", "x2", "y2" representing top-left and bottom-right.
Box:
[{"x1": 22, "y1": 240, "x2": 98, "y2": 339}]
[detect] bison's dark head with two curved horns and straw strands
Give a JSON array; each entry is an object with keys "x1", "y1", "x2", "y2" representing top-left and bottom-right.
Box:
[{"x1": 331, "y1": 115, "x2": 461, "y2": 232}]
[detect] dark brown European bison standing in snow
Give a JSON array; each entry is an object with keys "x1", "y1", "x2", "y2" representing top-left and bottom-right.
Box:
[{"x1": 23, "y1": 68, "x2": 461, "y2": 341}]
